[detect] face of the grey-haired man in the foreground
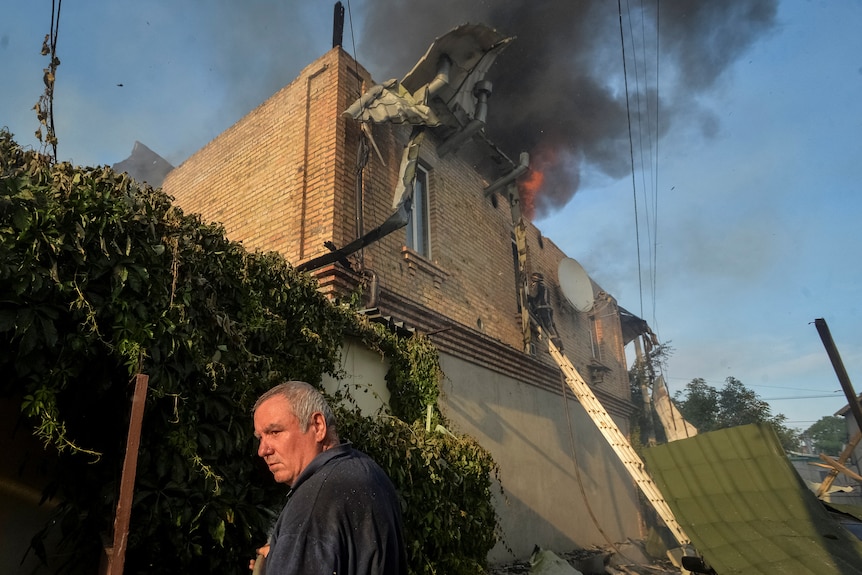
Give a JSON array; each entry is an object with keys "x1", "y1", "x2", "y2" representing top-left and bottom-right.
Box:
[{"x1": 254, "y1": 395, "x2": 323, "y2": 485}]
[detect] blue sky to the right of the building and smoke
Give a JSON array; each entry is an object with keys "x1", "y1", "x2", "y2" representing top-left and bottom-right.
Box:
[{"x1": 537, "y1": 2, "x2": 862, "y2": 429}]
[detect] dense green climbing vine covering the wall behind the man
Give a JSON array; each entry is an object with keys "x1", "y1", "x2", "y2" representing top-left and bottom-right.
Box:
[{"x1": 0, "y1": 132, "x2": 496, "y2": 573}]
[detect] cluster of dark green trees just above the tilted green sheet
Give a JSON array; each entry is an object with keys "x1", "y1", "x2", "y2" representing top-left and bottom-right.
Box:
[{"x1": 673, "y1": 377, "x2": 799, "y2": 451}]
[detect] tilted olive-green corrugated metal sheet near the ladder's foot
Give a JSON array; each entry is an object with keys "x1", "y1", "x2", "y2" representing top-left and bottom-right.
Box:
[{"x1": 645, "y1": 425, "x2": 862, "y2": 575}]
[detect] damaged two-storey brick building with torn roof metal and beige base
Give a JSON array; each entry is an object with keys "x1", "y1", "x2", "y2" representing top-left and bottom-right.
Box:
[{"x1": 164, "y1": 26, "x2": 642, "y2": 562}]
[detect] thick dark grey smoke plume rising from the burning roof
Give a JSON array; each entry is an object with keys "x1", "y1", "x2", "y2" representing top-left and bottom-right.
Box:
[{"x1": 357, "y1": 0, "x2": 777, "y2": 217}]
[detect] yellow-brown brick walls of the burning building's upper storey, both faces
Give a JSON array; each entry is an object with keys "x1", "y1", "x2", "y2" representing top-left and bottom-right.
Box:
[{"x1": 164, "y1": 48, "x2": 629, "y2": 410}]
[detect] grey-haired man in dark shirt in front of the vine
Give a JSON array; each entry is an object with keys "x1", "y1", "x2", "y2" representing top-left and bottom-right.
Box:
[{"x1": 252, "y1": 381, "x2": 407, "y2": 575}]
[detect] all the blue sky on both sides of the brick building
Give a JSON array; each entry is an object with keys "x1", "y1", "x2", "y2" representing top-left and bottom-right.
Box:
[{"x1": 0, "y1": 0, "x2": 862, "y2": 428}]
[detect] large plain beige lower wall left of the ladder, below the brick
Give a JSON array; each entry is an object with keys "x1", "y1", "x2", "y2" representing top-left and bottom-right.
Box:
[{"x1": 441, "y1": 356, "x2": 641, "y2": 562}]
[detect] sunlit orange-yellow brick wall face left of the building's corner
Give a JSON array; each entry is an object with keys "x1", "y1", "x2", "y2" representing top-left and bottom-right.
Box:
[{"x1": 163, "y1": 49, "x2": 361, "y2": 262}]
